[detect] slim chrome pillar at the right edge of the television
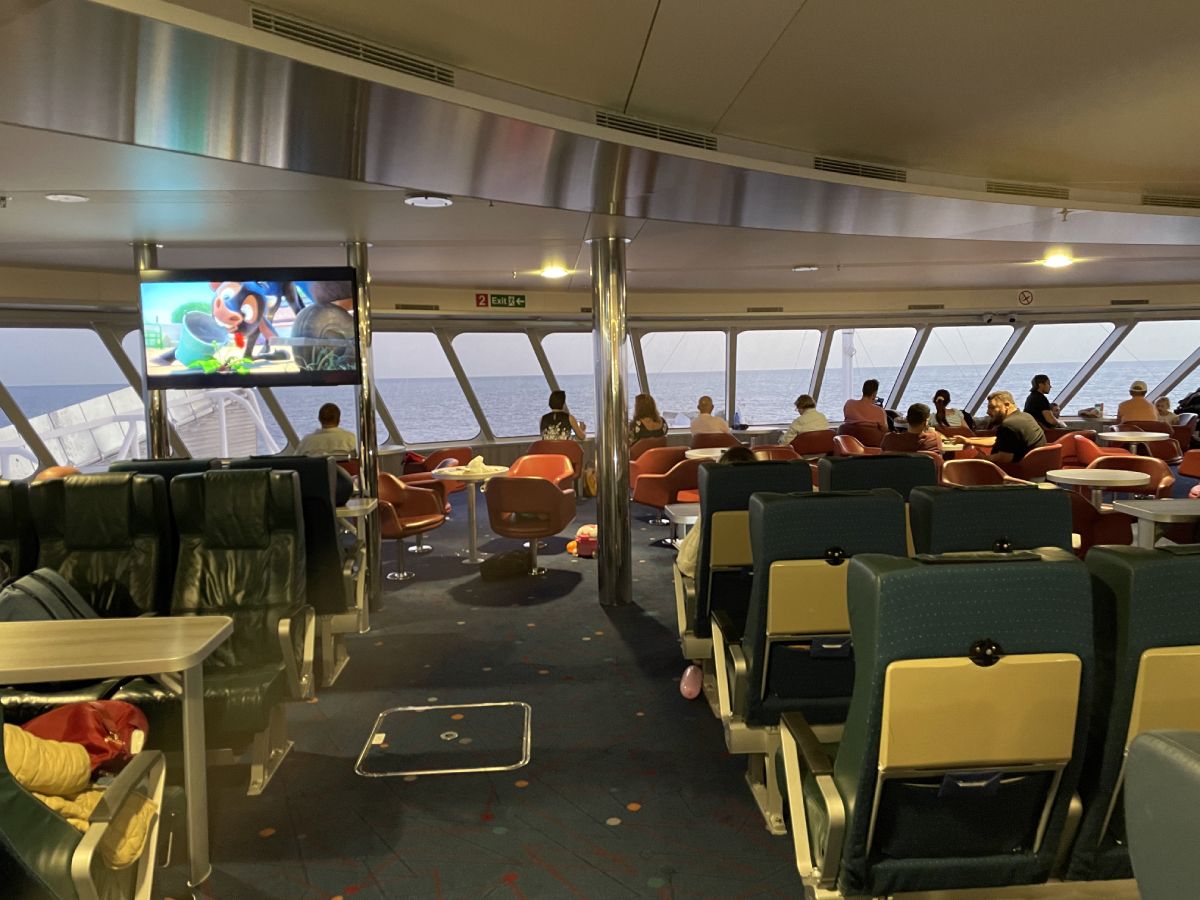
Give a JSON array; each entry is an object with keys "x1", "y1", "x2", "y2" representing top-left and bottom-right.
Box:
[{"x1": 346, "y1": 241, "x2": 382, "y2": 610}]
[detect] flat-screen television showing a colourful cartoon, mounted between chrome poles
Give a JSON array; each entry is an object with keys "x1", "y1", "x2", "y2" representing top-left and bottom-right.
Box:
[{"x1": 142, "y1": 268, "x2": 359, "y2": 390}]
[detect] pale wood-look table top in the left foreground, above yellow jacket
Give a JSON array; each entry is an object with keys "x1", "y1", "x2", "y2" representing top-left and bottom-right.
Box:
[{"x1": 0, "y1": 616, "x2": 233, "y2": 684}]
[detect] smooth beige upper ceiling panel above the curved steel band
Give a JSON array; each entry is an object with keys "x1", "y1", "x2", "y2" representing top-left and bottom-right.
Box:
[{"x1": 178, "y1": 0, "x2": 1200, "y2": 194}]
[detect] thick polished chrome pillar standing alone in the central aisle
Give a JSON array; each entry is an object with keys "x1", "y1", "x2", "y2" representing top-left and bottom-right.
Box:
[{"x1": 592, "y1": 238, "x2": 634, "y2": 606}]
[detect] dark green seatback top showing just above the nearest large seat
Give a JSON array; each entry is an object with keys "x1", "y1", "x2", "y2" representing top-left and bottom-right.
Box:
[{"x1": 908, "y1": 485, "x2": 1072, "y2": 553}]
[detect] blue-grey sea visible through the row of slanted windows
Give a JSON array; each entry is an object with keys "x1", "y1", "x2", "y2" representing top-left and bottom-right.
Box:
[{"x1": 7, "y1": 360, "x2": 1195, "y2": 458}]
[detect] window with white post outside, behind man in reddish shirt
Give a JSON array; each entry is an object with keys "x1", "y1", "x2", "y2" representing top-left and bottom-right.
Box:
[{"x1": 817, "y1": 328, "x2": 917, "y2": 420}]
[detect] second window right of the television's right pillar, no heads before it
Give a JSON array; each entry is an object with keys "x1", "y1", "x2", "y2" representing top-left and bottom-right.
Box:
[{"x1": 451, "y1": 331, "x2": 550, "y2": 438}]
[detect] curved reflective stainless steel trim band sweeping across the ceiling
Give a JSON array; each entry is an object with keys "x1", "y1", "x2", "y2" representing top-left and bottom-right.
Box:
[{"x1": 0, "y1": 0, "x2": 1200, "y2": 244}]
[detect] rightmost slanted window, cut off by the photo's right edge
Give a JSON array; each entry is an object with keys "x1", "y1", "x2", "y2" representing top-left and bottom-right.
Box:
[{"x1": 1072, "y1": 319, "x2": 1200, "y2": 415}]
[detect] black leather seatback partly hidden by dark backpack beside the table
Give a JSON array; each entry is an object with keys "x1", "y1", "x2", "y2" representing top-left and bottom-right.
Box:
[{"x1": 29, "y1": 473, "x2": 172, "y2": 617}]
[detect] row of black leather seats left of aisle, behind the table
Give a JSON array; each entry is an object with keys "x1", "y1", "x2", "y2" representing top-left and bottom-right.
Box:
[{"x1": 0, "y1": 457, "x2": 364, "y2": 793}]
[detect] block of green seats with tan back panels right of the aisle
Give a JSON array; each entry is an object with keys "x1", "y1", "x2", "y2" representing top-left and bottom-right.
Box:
[{"x1": 677, "y1": 457, "x2": 1200, "y2": 895}]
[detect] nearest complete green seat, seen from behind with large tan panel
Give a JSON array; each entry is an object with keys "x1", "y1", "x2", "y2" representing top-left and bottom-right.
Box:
[{"x1": 784, "y1": 550, "x2": 1094, "y2": 896}]
